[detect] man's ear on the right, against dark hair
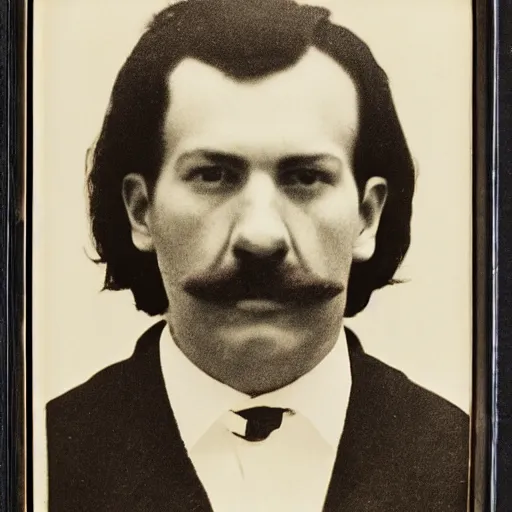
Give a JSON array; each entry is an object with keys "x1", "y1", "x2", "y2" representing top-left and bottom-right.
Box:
[{"x1": 352, "y1": 176, "x2": 388, "y2": 262}]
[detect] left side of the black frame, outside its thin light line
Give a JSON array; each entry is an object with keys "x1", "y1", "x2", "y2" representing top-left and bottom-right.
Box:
[{"x1": 0, "y1": 0, "x2": 26, "y2": 512}]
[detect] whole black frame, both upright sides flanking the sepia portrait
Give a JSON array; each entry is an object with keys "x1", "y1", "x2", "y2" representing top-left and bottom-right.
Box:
[{"x1": 0, "y1": 0, "x2": 512, "y2": 512}]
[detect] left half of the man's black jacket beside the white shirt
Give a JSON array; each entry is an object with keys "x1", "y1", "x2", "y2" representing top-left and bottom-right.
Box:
[{"x1": 46, "y1": 324, "x2": 200, "y2": 512}]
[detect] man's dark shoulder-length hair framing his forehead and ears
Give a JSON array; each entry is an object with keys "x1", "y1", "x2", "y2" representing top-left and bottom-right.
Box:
[{"x1": 88, "y1": 0, "x2": 414, "y2": 316}]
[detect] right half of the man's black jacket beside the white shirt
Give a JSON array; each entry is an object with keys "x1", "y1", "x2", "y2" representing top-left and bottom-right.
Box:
[{"x1": 326, "y1": 333, "x2": 469, "y2": 512}]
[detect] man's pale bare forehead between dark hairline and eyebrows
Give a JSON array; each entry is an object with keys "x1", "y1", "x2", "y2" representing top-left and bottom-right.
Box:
[{"x1": 165, "y1": 48, "x2": 358, "y2": 162}]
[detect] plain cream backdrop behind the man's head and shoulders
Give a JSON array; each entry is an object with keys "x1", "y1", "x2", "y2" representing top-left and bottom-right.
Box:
[{"x1": 33, "y1": 0, "x2": 472, "y2": 510}]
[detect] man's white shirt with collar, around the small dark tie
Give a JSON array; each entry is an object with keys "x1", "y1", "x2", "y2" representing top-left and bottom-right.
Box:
[{"x1": 160, "y1": 328, "x2": 352, "y2": 512}]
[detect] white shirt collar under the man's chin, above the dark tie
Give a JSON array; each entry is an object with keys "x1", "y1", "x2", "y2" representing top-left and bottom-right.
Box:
[{"x1": 160, "y1": 326, "x2": 352, "y2": 450}]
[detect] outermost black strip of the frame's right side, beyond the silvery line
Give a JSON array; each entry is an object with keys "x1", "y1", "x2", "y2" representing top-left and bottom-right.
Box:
[{"x1": 492, "y1": 0, "x2": 512, "y2": 511}]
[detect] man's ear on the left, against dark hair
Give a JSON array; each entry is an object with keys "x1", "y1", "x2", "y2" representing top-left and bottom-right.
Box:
[{"x1": 123, "y1": 173, "x2": 153, "y2": 252}]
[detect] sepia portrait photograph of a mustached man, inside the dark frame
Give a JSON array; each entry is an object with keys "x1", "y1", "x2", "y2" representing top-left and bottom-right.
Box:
[{"x1": 32, "y1": 0, "x2": 473, "y2": 512}]
